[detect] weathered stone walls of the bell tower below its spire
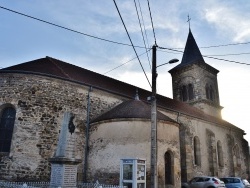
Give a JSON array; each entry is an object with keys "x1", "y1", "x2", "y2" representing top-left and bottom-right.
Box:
[{"x1": 172, "y1": 64, "x2": 221, "y2": 117}]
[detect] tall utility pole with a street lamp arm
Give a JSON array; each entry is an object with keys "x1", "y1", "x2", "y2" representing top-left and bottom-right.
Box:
[{"x1": 150, "y1": 45, "x2": 179, "y2": 188}]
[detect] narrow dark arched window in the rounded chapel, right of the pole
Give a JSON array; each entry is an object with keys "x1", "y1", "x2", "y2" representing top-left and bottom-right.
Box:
[{"x1": 165, "y1": 151, "x2": 174, "y2": 185}]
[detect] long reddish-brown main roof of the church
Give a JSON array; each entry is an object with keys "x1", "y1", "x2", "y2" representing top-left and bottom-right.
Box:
[{"x1": 0, "y1": 56, "x2": 240, "y2": 130}]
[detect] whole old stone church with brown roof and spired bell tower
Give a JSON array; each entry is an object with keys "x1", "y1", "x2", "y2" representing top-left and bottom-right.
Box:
[{"x1": 0, "y1": 30, "x2": 249, "y2": 188}]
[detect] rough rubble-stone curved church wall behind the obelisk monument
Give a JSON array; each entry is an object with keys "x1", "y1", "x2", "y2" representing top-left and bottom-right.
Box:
[{"x1": 0, "y1": 73, "x2": 121, "y2": 181}]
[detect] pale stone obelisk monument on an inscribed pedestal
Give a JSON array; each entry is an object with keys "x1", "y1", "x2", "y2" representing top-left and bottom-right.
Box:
[{"x1": 49, "y1": 112, "x2": 81, "y2": 188}]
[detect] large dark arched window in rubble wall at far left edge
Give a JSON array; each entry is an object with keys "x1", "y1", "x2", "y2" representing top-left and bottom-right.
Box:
[{"x1": 0, "y1": 107, "x2": 16, "y2": 152}]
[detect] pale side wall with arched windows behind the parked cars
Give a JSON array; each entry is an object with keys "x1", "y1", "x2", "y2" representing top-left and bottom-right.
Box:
[{"x1": 179, "y1": 115, "x2": 248, "y2": 181}]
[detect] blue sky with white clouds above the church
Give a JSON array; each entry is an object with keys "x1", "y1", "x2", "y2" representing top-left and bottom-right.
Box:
[{"x1": 0, "y1": 0, "x2": 250, "y2": 142}]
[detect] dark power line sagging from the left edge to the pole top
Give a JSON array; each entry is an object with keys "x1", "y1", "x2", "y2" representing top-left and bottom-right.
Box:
[{"x1": 0, "y1": 6, "x2": 145, "y2": 48}]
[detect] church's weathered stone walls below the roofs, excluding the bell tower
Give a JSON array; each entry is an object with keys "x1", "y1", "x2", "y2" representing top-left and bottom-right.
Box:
[{"x1": 0, "y1": 73, "x2": 249, "y2": 183}]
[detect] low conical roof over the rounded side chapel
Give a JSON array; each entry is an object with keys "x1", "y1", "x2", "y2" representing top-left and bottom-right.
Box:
[{"x1": 91, "y1": 99, "x2": 177, "y2": 123}]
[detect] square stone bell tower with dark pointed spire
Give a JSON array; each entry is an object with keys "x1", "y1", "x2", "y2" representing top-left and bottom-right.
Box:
[{"x1": 169, "y1": 29, "x2": 222, "y2": 117}]
